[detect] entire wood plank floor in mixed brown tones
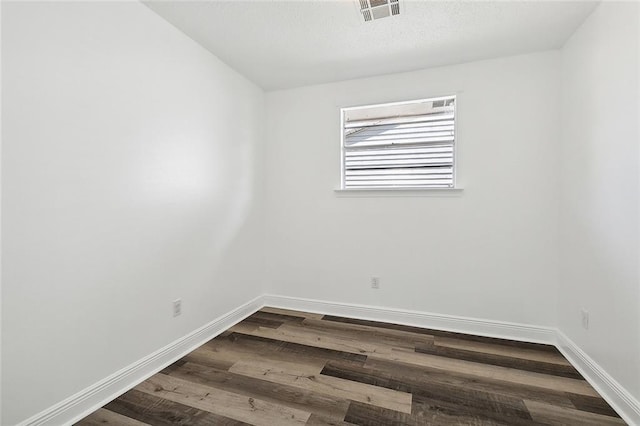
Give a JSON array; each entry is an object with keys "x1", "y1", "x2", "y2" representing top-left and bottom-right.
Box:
[{"x1": 78, "y1": 308, "x2": 625, "y2": 426}]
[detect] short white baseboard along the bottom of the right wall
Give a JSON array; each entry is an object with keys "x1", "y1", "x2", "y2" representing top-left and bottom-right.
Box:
[{"x1": 556, "y1": 330, "x2": 640, "y2": 425}]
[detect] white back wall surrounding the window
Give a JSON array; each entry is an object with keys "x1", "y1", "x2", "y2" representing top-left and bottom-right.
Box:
[{"x1": 266, "y1": 52, "x2": 559, "y2": 326}]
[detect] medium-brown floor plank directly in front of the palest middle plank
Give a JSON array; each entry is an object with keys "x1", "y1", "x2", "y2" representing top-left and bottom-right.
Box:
[{"x1": 165, "y1": 363, "x2": 349, "y2": 420}]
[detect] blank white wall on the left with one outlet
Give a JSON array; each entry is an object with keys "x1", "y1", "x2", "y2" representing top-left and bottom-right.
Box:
[{"x1": 2, "y1": 2, "x2": 264, "y2": 425}]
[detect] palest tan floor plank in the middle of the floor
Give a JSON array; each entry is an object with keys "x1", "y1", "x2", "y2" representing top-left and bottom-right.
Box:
[{"x1": 229, "y1": 361, "x2": 411, "y2": 413}]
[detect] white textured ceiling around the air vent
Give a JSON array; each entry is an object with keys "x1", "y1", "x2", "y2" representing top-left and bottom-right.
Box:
[{"x1": 145, "y1": 0, "x2": 597, "y2": 90}]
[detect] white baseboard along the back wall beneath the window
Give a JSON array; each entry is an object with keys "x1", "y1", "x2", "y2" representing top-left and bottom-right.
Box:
[{"x1": 263, "y1": 294, "x2": 556, "y2": 345}]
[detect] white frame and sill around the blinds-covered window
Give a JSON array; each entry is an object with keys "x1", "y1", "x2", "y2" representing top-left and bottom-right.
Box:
[{"x1": 336, "y1": 94, "x2": 462, "y2": 193}]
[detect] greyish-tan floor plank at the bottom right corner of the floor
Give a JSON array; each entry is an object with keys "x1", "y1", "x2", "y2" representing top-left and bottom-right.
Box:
[{"x1": 524, "y1": 400, "x2": 626, "y2": 426}]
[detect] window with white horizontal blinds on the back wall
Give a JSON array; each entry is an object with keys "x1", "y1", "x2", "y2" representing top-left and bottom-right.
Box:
[{"x1": 341, "y1": 96, "x2": 456, "y2": 189}]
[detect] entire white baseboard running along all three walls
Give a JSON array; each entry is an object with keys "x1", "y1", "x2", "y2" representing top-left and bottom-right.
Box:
[{"x1": 18, "y1": 294, "x2": 640, "y2": 426}]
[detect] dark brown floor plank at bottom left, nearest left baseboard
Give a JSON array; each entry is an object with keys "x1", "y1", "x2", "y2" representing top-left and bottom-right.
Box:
[{"x1": 105, "y1": 389, "x2": 246, "y2": 426}]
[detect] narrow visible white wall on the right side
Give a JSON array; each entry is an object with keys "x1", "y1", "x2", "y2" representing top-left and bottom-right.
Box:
[{"x1": 558, "y1": 2, "x2": 640, "y2": 400}]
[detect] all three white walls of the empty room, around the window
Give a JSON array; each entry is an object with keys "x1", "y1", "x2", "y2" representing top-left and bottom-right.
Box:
[{"x1": 1, "y1": 2, "x2": 640, "y2": 425}]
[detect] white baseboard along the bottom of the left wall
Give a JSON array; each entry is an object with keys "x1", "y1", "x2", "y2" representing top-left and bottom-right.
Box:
[{"x1": 18, "y1": 296, "x2": 263, "y2": 426}]
